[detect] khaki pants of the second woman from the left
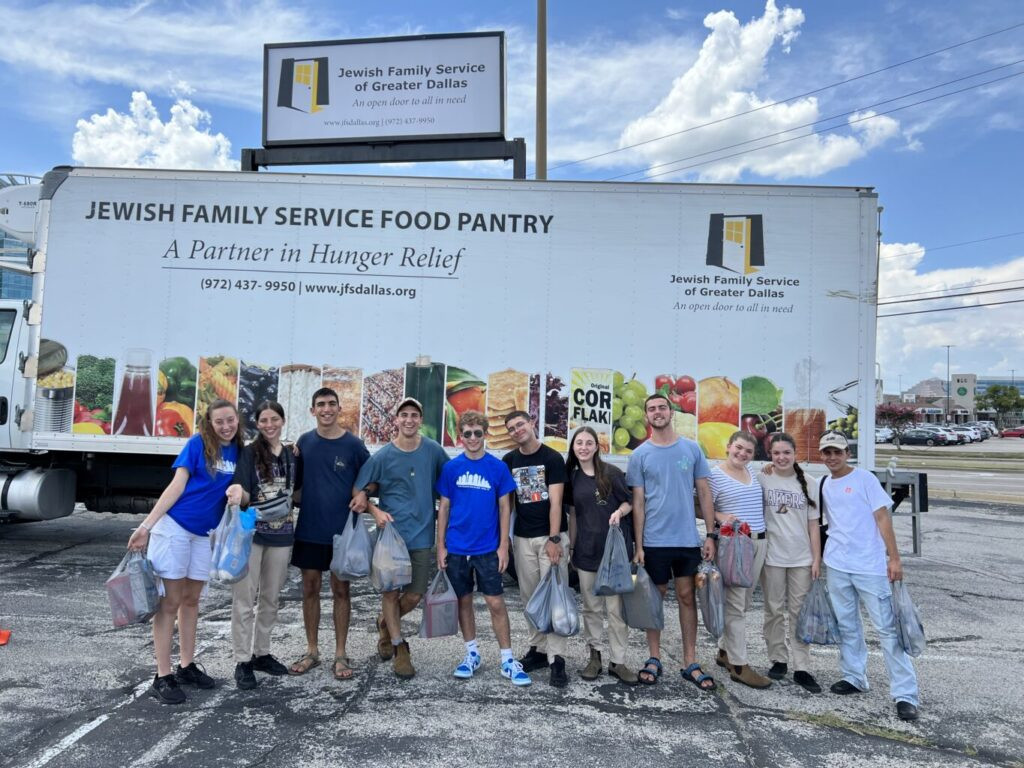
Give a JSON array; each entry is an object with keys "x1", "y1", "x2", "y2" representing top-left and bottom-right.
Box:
[{"x1": 231, "y1": 543, "x2": 292, "y2": 663}]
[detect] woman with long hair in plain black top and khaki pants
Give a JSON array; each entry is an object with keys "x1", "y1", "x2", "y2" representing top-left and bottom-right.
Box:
[{"x1": 565, "y1": 427, "x2": 637, "y2": 685}]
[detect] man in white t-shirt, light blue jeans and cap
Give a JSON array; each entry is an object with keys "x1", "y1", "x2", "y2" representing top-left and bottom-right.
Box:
[{"x1": 818, "y1": 432, "x2": 919, "y2": 720}]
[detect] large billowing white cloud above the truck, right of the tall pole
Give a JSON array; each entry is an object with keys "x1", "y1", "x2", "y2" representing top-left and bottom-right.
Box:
[{"x1": 606, "y1": 0, "x2": 900, "y2": 181}]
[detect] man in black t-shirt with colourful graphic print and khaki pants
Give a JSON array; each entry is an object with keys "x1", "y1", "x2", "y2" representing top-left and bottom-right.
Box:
[{"x1": 504, "y1": 411, "x2": 568, "y2": 688}]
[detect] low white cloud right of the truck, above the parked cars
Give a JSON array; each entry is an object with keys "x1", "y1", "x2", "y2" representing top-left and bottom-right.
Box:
[{"x1": 877, "y1": 243, "x2": 1024, "y2": 391}]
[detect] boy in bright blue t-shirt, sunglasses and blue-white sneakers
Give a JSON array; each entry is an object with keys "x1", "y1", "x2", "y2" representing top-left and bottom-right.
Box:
[{"x1": 437, "y1": 411, "x2": 530, "y2": 685}]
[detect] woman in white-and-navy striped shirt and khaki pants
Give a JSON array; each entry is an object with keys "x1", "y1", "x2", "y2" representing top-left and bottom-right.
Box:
[{"x1": 708, "y1": 431, "x2": 771, "y2": 688}]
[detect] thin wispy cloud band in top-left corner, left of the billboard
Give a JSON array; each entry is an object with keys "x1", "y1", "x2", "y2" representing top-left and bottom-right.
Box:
[{"x1": 0, "y1": 0, "x2": 316, "y2": 112}]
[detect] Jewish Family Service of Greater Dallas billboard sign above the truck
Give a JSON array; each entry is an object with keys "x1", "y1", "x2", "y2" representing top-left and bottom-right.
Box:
[{"x1": 263, "y1": 32, "x2": 505, "y2": 146}]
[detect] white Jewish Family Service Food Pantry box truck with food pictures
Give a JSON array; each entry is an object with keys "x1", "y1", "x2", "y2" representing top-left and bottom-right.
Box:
[{"x1": 0, "y1": 167, "x2": 879, "y2": 520}]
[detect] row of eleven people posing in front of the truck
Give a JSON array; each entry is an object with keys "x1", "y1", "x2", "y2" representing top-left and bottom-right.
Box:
[{"x1": 128, "y1": 388, "x2": 918, "y2": 720}]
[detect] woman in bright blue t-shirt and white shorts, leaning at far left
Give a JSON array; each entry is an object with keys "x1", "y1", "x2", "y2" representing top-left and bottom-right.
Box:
[{"x1": 128, "y1": 400, "x2": 242, "y2": 703}]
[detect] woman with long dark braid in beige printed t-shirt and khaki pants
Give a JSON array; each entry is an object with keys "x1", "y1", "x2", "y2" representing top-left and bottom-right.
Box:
[{"x1": 760, "y1": 432, "x2": 821, "y2": 693}]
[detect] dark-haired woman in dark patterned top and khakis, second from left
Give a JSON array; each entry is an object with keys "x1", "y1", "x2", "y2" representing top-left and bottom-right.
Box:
[{"x1": 227, "y1": 400, "x2": 295, "y2": 689}]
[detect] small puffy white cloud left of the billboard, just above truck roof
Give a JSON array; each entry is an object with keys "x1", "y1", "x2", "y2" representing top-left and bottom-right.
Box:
[{"x1": 72, "y1": 91, "x2": 239, "y2": 171}]
